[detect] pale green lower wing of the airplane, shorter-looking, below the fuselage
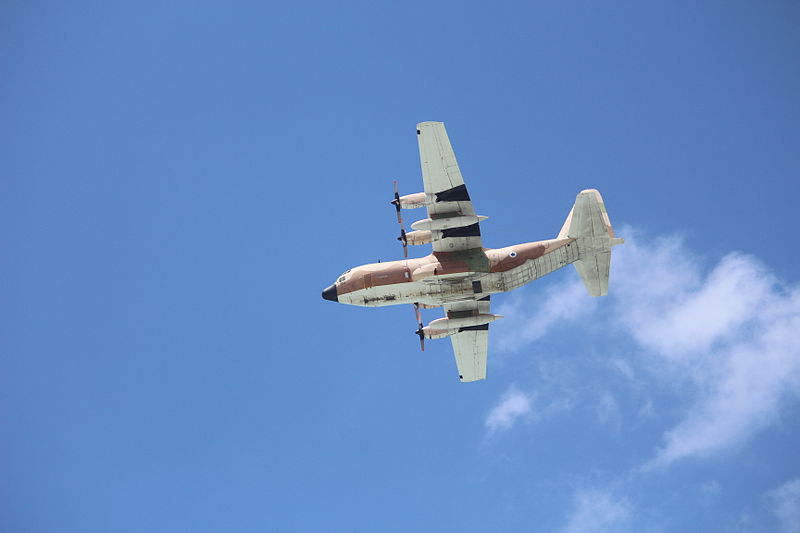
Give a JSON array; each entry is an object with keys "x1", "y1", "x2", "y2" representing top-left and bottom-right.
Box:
[{"x1": 444, "y1": 296, "x2": 489, "y2": 382}]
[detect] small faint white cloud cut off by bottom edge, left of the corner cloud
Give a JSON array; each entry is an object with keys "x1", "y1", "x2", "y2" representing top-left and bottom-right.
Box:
[{"x1": 562, "y1": 490, "x2": 631, "y2": 533}]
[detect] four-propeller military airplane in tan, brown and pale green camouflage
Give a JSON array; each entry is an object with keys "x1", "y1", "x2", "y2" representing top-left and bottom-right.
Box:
[{"x1": 322, "y1": 122, "x2": 624, "y2": 382}]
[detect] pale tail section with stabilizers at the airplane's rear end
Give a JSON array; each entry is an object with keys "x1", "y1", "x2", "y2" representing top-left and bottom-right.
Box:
[{"x1": 558, "y1": 189, "x2": 624, "y2": 296}]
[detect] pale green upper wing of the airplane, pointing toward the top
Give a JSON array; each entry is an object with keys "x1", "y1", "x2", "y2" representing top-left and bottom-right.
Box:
[{"x1": 417, "y1": 122, "x2": 483, "y2": 252}]
